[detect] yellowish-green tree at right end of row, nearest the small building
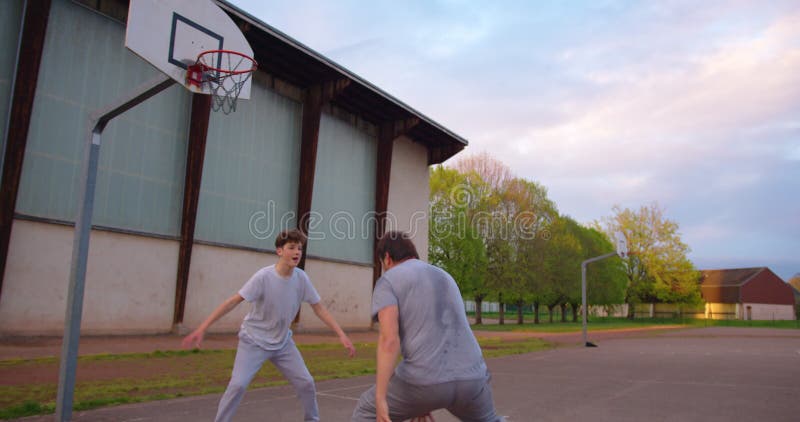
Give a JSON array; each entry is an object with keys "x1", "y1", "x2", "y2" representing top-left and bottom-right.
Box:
[{"x1": 598, "y1": 203, "x2": 701, "y2": 318}]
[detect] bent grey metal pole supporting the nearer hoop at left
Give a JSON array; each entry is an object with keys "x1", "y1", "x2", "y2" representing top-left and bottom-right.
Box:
[{"x1": 56, "y1": 75, "x2": 175, "y2": 422}]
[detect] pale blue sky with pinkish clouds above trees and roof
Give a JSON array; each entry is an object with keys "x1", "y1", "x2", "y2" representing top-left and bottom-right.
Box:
[{"x1": 232, "y1": 0, "x2": 800, "y2": 280}]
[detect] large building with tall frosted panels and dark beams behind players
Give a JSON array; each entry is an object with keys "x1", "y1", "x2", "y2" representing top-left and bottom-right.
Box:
[{"x1": 0, "y1": 0, "x2": 466, "y2": 335}]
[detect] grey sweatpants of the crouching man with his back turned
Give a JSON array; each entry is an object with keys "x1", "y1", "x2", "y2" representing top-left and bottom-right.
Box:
[{"x1": 351, "y1": 375, "x2": 502, "y2": 422}]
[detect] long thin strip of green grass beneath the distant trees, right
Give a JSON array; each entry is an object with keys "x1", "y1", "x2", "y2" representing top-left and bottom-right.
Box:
[{"x1": 472, "y1": 315, "x2": 800, "y2": 333}]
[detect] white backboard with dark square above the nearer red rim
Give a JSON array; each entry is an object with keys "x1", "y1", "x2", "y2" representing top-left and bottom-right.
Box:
[{"x1": 125, "y1": 0, "x2": 253, "y2": 99}]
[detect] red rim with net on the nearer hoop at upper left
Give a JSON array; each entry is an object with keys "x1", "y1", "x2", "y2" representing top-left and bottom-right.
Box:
[{"x1": 186, "y1": 50, "x2": 258, "y2": 114}]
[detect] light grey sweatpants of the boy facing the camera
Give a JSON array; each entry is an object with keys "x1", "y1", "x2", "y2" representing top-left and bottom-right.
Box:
[{"x1": 219, "y1": 335, "x2": 319, "y2": 422}]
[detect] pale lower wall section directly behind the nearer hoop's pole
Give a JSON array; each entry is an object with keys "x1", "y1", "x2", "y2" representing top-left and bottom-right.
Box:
[{"x1": 0, "y1": 220, "x2": 178, "y2": 335}]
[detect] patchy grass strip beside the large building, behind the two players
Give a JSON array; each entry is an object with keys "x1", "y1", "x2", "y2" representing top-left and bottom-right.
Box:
[{"x1": 0, "y1": 338, "x2": 549, "y2": 419}]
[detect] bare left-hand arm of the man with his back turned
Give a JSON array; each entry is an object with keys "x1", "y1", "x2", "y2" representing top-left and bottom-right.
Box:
[{"x1": 375, "y1": 305, "x2": 400, "y2": 422}]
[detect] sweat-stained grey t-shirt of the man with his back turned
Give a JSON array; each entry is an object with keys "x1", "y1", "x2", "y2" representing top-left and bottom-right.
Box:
[{"x1": 372, "y1": 259, "x2": 487, "y2": 385}]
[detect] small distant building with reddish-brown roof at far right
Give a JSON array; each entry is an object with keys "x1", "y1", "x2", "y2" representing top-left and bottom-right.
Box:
[{"x1": 700, "y1": 267, "x2": 795, "y2": 320}]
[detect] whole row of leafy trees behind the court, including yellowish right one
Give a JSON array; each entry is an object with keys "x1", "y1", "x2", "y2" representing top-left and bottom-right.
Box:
[{"x1": 428, "y1": 154, "x2": 700, "y2": 324}]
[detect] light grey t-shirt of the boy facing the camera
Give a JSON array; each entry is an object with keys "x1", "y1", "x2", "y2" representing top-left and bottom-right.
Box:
[{"x1": 239, "y1": 265, "x2": 320, "y2": 350}]
